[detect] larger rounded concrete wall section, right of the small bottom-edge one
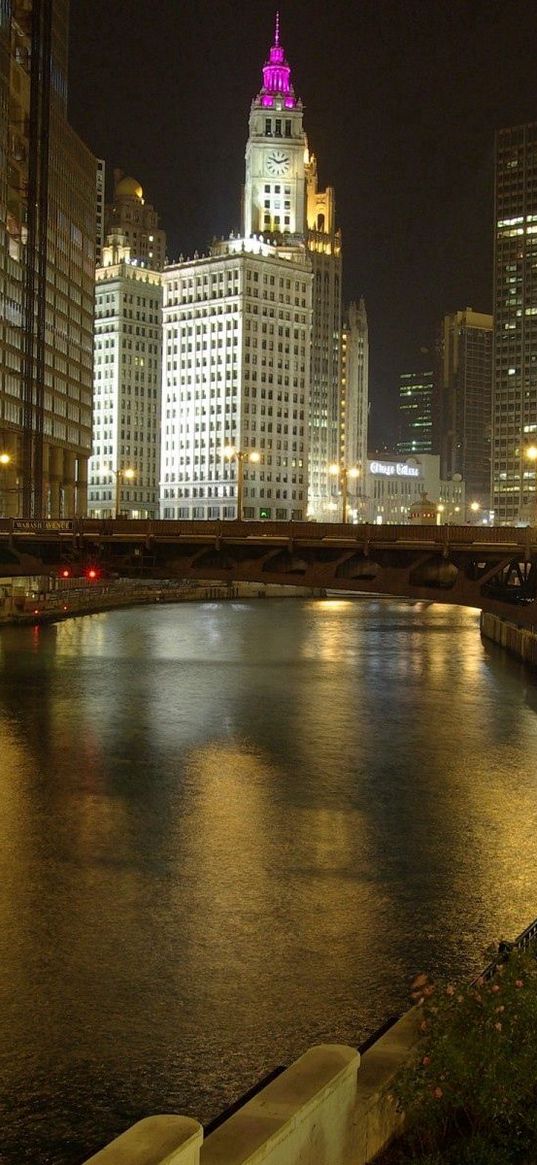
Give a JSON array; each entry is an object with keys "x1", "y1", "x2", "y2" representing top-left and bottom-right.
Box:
[{"x1": 200, "y1": 1044, "x2": 360, "y2": 1165}]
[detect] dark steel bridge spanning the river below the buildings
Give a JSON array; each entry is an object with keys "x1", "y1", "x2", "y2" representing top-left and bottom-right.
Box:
[{"x1": 0, "y1": 518, "x2": 537, "y2": 627}]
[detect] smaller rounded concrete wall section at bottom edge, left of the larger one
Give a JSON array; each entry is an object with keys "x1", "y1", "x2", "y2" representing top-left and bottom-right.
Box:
[{"x1": 86, "y1": 1116, "x2": 203, "y2": 1165}]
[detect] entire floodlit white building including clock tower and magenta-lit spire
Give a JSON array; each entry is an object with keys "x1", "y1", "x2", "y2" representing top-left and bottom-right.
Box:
[{"x1": 161, "y1": 17, "x2": 312, "y2": 521}]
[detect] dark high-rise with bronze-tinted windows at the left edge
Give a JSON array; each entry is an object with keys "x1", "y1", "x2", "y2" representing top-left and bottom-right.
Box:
[{"x1": 0, "y1": 0, "x2": 96, "y2": 517}]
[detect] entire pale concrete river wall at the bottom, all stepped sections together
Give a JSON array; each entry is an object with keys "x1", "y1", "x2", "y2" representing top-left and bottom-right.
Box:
[{"x1": 82, "y1": 1008, "x2": 419, "y2": 1165}]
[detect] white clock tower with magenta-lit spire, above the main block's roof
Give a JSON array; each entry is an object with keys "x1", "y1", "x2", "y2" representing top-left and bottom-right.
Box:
[{"x1": 243, "y1": 16, "x2": 308, "y2": 238}]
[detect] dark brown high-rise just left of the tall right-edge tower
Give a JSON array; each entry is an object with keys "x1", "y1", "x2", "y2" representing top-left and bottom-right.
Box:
[{"x1": 438, "y1": 308, "x2": 493, "y2": 511}]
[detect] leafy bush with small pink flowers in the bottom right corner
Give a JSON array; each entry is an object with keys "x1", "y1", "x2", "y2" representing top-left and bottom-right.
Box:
[{"x1": 382, "y1": 949, "x2": 537, "y2": 1165}]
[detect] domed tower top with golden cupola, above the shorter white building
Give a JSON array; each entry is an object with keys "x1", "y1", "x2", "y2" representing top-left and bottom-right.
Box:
[{"x1": 105, "y1": 170, "x2": 165, "y2": 271}]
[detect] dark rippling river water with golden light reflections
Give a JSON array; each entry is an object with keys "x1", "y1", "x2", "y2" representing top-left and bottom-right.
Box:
[{"x1": 0, "y1": 600, "x2": 537, "y2": 1165}]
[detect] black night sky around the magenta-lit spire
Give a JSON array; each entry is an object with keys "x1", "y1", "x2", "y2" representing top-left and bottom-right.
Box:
[{"x1": 70, "y1": 0, "x2": 537, "y2": 444}]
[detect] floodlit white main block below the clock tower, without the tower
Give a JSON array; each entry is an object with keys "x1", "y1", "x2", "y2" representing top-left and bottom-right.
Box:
[{"x1": 161, "y1": 239, "x2": 312, "y2": 521}]
